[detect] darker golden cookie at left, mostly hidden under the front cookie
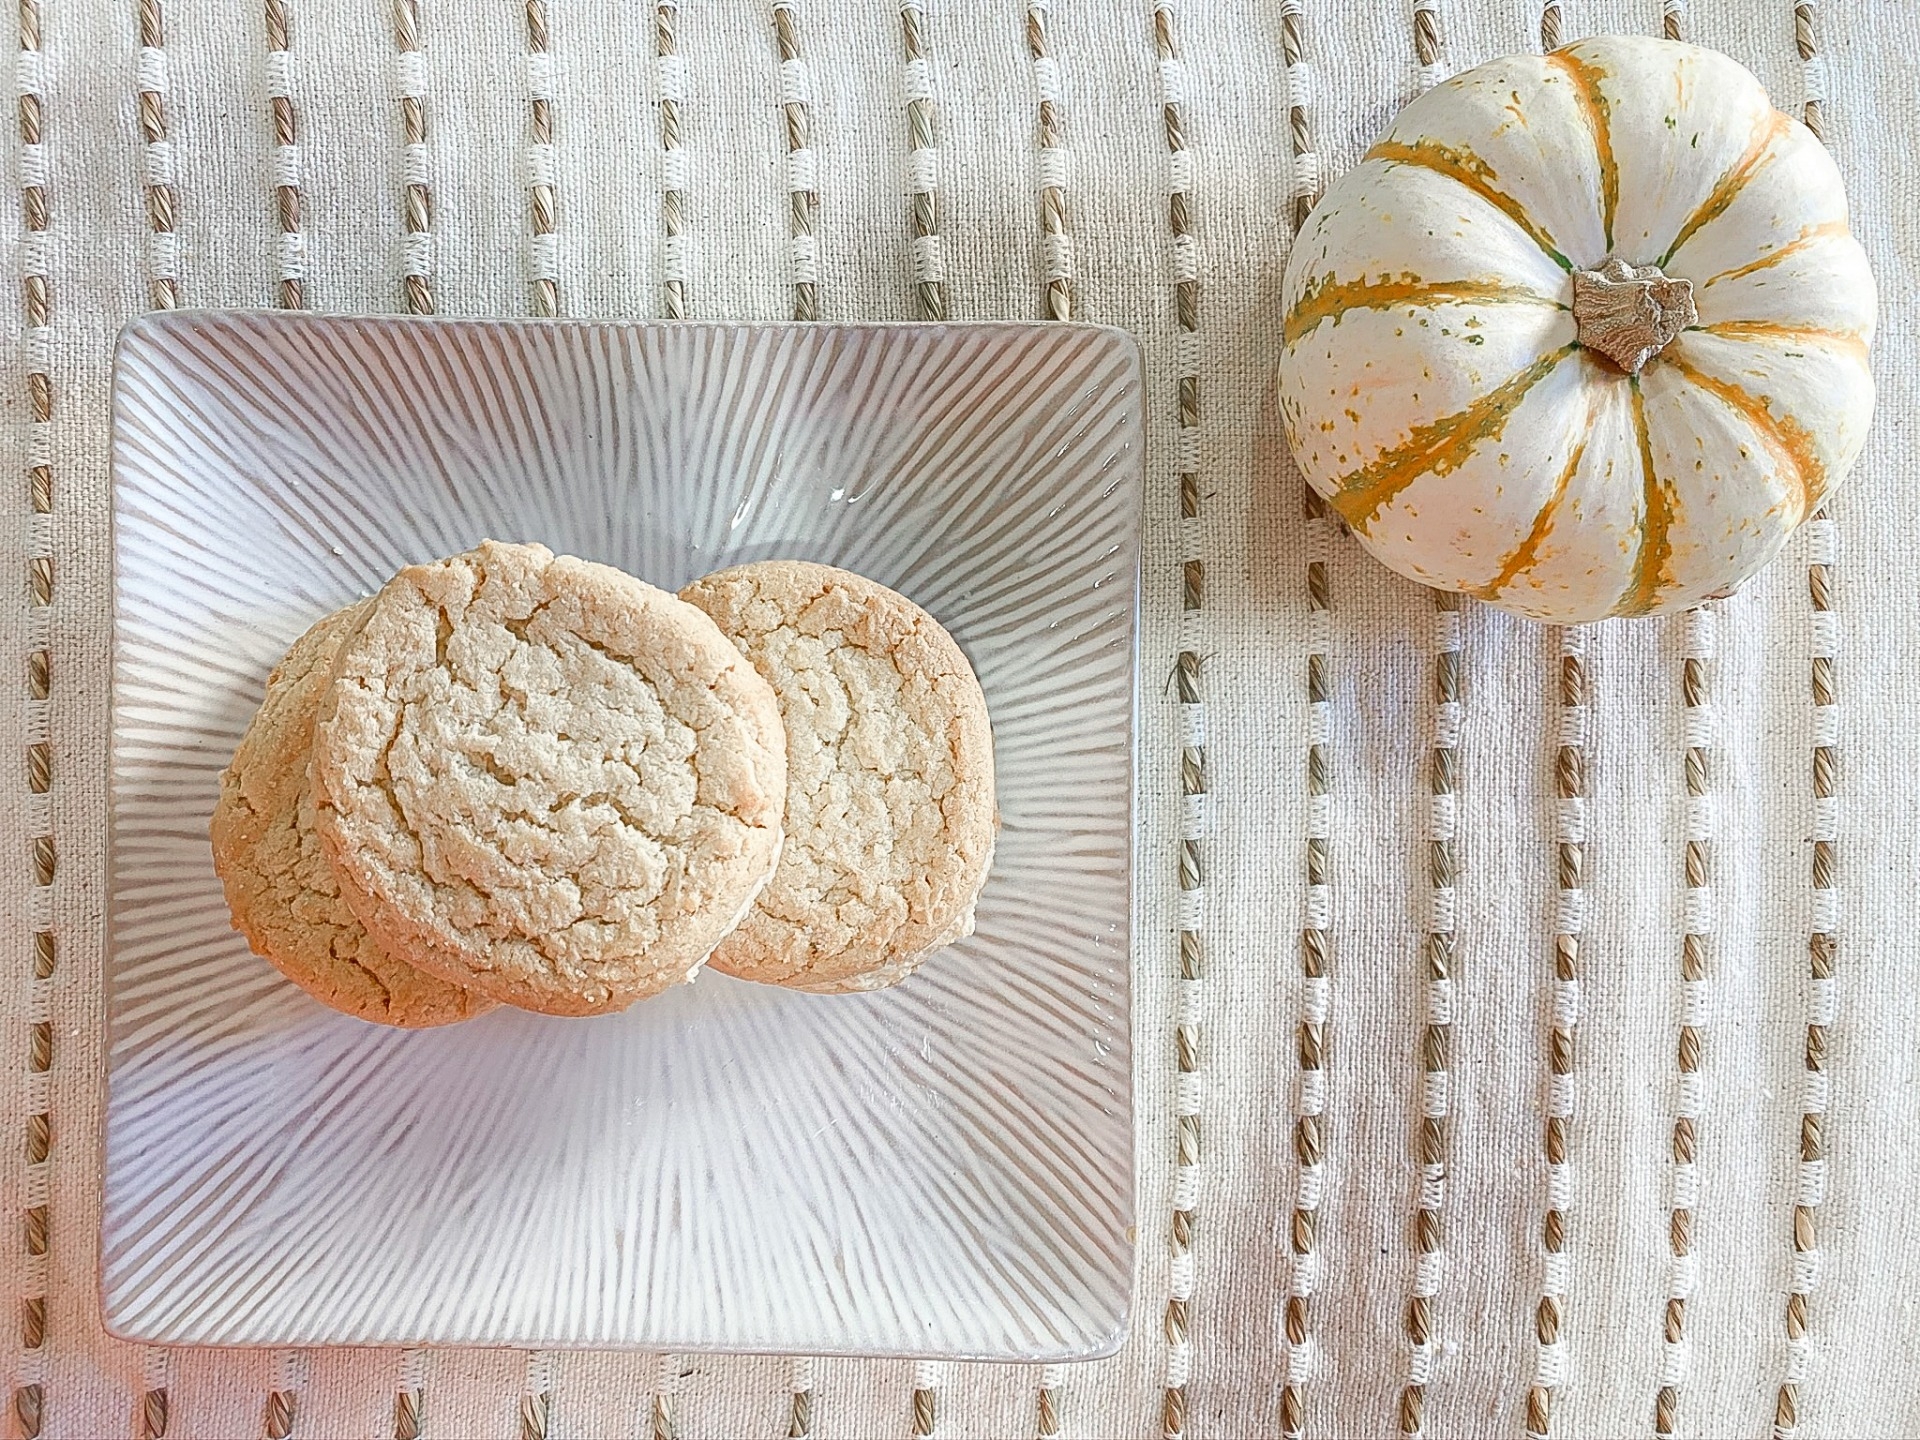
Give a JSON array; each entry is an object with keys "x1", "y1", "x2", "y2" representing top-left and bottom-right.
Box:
[{"x1": 209, "y1": 601, "x2": 493, "y2": 1029}]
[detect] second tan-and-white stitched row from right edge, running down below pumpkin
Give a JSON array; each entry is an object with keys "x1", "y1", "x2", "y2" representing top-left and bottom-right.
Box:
[{"x1": 1653, "y1": 605, "x2": 1713, "y2": 1434}]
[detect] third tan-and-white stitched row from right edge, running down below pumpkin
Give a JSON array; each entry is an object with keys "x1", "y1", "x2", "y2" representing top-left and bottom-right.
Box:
[{"x1": 1526, "y1": 628, "x2": 1590, "y2": 1438}]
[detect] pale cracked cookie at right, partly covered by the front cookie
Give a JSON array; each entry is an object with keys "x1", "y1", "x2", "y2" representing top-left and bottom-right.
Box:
[{"x1": 680, "y1": 561, "x2": 995, "y2": 993}]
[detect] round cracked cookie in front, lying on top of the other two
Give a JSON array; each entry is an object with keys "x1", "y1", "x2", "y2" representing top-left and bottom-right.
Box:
[{"x1": 311, "y1": 541, "x2": 787, "y2": 1016}]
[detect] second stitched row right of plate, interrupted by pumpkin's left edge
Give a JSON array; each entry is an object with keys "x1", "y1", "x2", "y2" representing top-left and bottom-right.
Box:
[{"x1": 1281, "y1": 0, "x2": 1334, "y2": 1440}]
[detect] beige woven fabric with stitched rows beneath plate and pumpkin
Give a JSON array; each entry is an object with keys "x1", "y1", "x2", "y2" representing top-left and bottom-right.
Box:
[{"x1": 0, "y1": 0, "x2": 1920, "y2": 1440}]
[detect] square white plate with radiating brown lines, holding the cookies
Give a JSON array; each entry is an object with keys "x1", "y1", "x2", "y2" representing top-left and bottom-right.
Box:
[{"x1": 102, "y1": 313, "x2": 1142, "y2": 1361}]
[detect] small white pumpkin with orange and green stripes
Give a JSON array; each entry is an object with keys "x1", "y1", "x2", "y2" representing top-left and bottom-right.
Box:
[{"x1": 1279, "y1": 36, "x2": 1874, "y2": 624}]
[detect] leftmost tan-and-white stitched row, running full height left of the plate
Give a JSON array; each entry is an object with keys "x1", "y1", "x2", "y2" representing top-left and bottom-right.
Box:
[{"x1": 12, "y1": 0, "x2": 58, "y2": 1440}]
